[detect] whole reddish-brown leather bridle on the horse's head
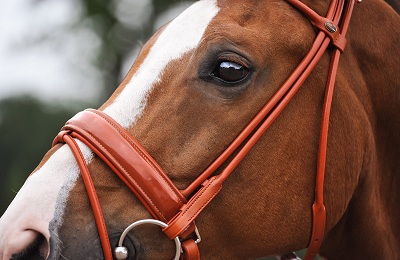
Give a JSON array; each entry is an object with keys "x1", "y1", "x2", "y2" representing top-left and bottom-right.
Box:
[{"x1": 53, "y1": 0, "x2": 360, "y2": 259}]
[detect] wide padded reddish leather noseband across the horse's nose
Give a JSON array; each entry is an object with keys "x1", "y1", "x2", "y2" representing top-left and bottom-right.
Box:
[{"x1": 58, "y1": 110, "x2": 186, "y2": 222}]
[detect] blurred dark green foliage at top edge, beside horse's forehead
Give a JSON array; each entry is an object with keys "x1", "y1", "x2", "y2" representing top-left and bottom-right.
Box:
[{"x1": 80, "y1": 0, "x2": 193, "y2": 97}]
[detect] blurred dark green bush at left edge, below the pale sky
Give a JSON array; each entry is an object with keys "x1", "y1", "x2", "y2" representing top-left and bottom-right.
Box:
[{"x1": 0, "y1": 96, "x2": 84, "y2": 214}]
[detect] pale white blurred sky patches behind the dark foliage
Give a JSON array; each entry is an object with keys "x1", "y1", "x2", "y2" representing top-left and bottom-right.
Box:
[{"x1": 0, "y1": 0, "x2": 189, "y2": 102}]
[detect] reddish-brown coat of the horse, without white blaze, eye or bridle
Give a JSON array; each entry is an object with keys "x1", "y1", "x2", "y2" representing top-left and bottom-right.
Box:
[{"x1": 0, "y1": 0, "x2": 400, "y2": 259}]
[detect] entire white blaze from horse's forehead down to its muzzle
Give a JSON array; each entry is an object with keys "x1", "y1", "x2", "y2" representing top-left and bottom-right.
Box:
[{"x1": 0, "y1": 0, "x2": 219, "y2": 259}]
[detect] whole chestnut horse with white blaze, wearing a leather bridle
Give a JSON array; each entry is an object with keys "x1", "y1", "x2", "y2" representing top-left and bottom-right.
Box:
[{"x1": 0, "y1": 0, "x2": 400, "y2": 259}]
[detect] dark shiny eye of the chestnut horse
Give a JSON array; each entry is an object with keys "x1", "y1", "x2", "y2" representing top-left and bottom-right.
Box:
[{"x1": 211, "y1": 61, "x2": 249, "y2": 83}]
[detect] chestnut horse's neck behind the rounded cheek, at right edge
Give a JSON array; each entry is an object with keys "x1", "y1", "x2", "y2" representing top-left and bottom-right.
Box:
[{"x1": 321, "y1": 1, "x2": 400, "y2": 259}]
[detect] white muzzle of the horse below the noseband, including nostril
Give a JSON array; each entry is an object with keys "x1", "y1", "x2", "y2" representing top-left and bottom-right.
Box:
[{"x1": 0, "y1": 143, "x2": 92, "y2": 259}]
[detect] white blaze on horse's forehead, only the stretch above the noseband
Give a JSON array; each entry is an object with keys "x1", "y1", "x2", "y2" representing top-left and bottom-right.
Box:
[{"x1": 104, "y1": 0, "x2": 219, "y2": 128}]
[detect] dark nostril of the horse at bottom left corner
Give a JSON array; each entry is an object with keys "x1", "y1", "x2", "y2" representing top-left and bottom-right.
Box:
[{"x1": 10, "y1": 230, "x2": 49, "y2": 260}]
